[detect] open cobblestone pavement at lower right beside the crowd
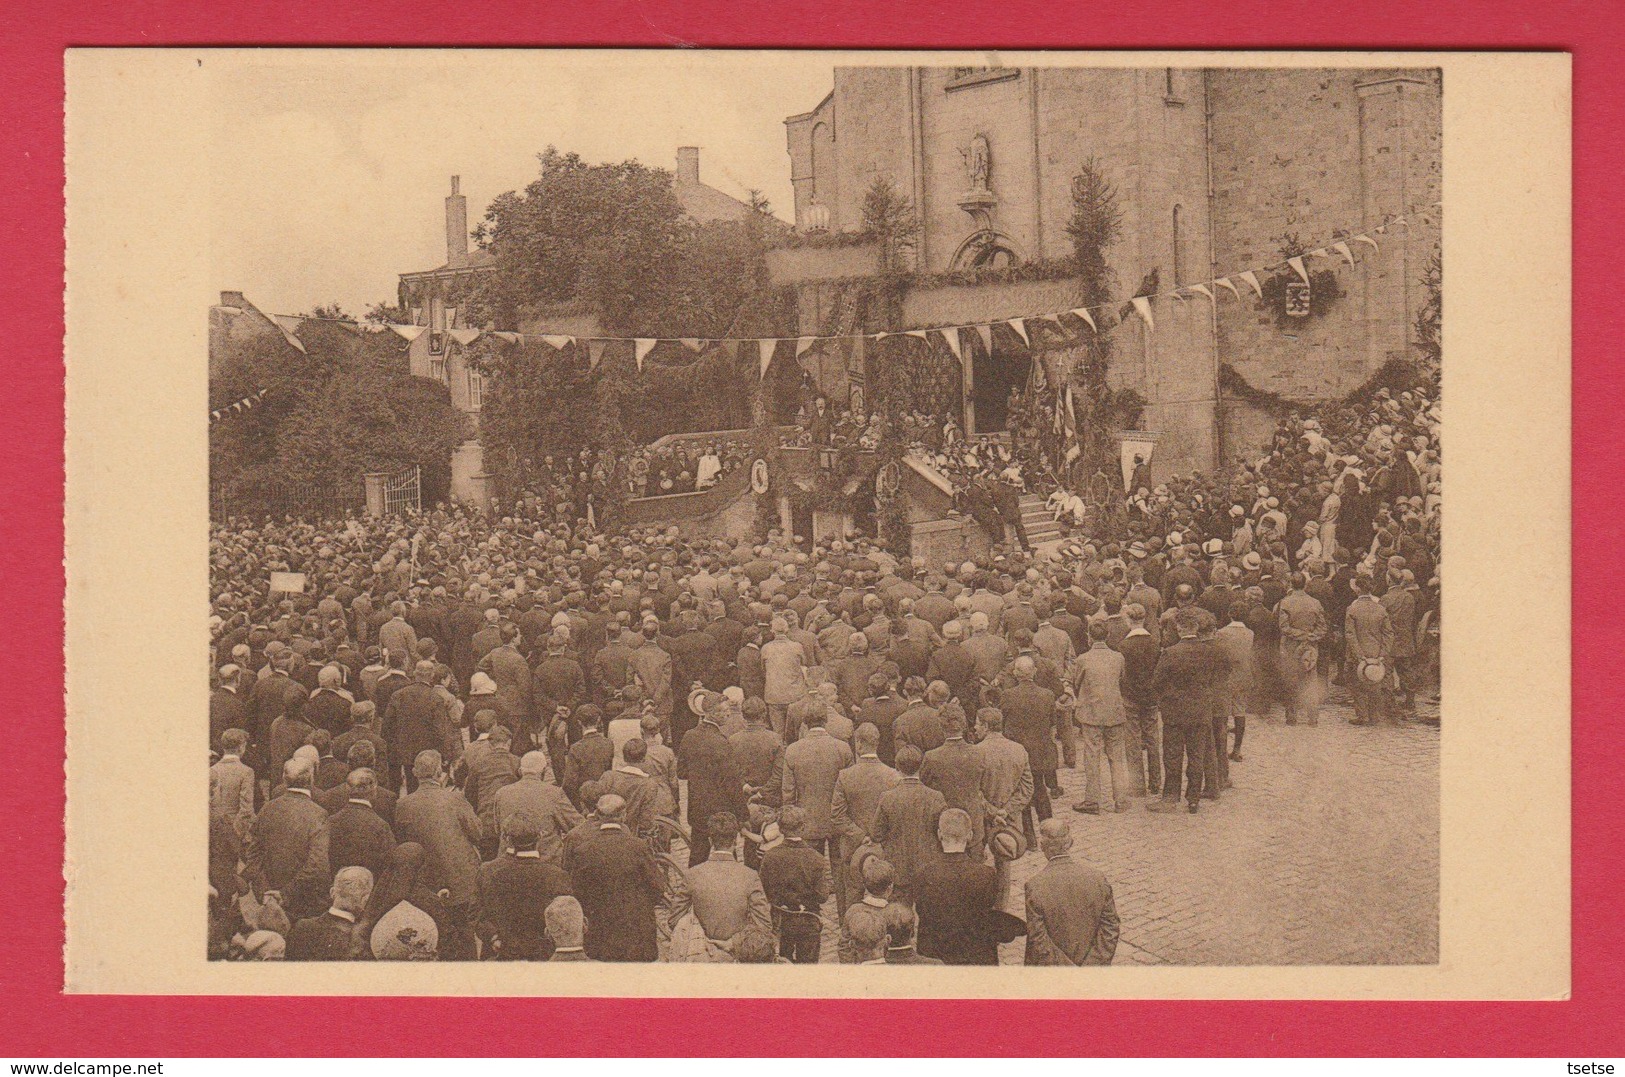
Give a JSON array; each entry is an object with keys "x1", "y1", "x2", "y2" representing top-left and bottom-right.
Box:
[{"x1": 806, "y1": 703, "x2": 1440, "y2": 965}]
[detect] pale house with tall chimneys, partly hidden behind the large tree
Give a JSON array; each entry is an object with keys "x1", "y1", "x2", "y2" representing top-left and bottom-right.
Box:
[{"x1": 398, "y1": 146, "x2": 767, "y2": 505}]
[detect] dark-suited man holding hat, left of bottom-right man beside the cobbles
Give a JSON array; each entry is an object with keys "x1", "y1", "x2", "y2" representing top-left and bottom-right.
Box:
[{"x1": 915, "y1": 807, "x2": 999, "y2": 965}]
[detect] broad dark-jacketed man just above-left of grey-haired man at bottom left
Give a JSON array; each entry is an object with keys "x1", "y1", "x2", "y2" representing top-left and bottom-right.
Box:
[{"x1": 244, "y1": 759, "x2": 332, "y2": 918}]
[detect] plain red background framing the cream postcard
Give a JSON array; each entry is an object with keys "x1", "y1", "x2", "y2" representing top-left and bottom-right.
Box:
[{"x1": 0, "y1": 0, "x2": 1625, "y2": 1058}]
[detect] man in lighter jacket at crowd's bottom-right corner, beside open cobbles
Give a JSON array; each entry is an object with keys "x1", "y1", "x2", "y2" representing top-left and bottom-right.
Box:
[{"x1": 1025, "y1": 819, "x2": 1120, "y2": 965}]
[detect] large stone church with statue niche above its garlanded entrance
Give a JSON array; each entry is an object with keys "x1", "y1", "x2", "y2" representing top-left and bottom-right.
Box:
[{"x1": 780, "y1": 67, "x2": 1441, "y2": 476}]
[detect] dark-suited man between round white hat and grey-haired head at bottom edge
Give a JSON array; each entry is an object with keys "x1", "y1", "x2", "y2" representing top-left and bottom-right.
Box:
[{"x1": 476, "y1": 812, "x2": 570, "y2": 962}]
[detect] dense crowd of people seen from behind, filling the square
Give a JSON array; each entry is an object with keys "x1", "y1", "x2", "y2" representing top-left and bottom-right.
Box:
[{"x1": 210, "y1": 373, "x2": 1440, "y2": 965}]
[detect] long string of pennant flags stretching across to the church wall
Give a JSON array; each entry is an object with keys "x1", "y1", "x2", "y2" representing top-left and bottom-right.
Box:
[{"x1": 253, "y1": 201, "x2": 1443, "y2": 377}]
